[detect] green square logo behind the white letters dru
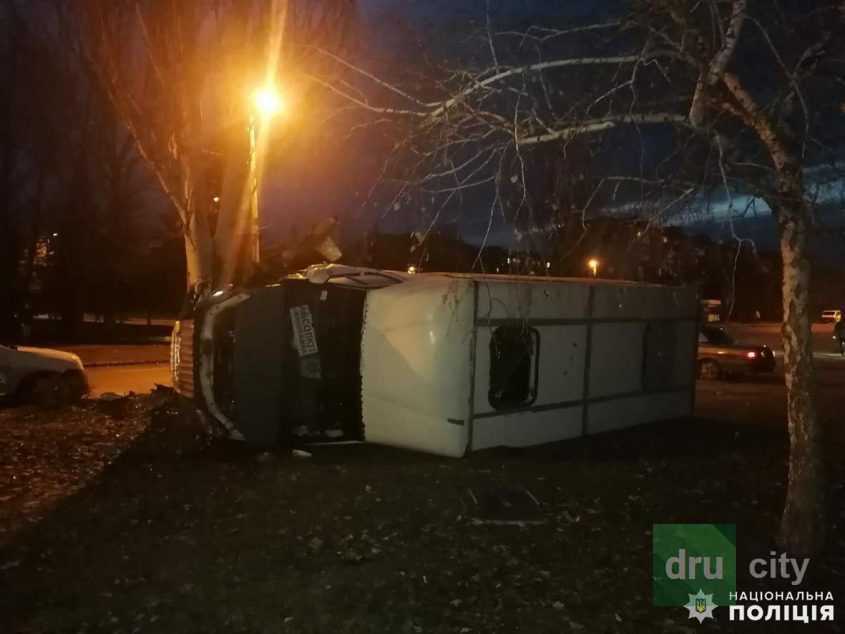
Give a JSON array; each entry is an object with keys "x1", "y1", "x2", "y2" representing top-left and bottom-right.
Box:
[{"x1": 651, "y1": 524, "x2": 736, "y2": 607}]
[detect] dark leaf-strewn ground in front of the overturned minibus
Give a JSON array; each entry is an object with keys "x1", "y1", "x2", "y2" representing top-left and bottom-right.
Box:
[{"x1": 0, "y1": 376, "x2": 845, "y2": 634}]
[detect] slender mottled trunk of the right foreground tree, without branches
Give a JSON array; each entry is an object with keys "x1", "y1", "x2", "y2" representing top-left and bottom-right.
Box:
[{"x1": 773, "y1": 185, "x2": 827, "y2": 554}]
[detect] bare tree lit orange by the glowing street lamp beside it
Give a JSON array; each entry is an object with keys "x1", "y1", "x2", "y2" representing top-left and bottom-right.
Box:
[{"x1": 77, "y1": 0, "x2": 354, "y2": 288}]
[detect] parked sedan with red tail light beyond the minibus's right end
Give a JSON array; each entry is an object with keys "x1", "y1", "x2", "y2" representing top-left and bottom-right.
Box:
[{"x1": 698, "y1": 326, "x2": 775, "y2": 380}]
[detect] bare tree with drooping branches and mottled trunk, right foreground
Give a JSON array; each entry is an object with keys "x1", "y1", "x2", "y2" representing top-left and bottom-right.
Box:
[{"x1": 327, "y1": 0, "x2": 845, "y2": 552}]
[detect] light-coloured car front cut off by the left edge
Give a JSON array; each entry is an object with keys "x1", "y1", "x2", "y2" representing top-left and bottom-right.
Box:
[{"x1": 0, "y1": 345, "x2": 88, "y2": 405}]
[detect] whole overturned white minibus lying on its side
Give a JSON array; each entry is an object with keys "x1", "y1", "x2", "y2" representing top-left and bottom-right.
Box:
[{"x1": 172, "y1": 265, "x2": 699, "y2": 456}]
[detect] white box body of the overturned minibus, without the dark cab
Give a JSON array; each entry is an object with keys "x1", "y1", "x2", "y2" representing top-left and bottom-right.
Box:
[{"x1": 361, "y1": 274, "x2": 698, "y2": 456}]
